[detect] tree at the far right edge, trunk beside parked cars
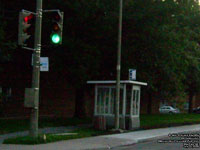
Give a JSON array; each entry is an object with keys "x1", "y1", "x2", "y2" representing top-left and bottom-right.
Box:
[{"x1": 175, "y1": 0, "x2": 200, "y2": 113}]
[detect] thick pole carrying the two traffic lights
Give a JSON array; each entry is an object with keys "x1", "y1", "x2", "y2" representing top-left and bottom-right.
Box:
[{"x1": 29, "y1": 0, "x2": 42, "y2": 137}]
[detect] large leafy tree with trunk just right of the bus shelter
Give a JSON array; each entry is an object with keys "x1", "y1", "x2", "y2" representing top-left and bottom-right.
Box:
[{"x1": 122, "y1": 0, "x2": 199, "y2": 113}]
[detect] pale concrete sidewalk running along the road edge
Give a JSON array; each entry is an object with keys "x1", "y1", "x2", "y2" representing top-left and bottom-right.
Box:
[{"x1": 0, "y1": 125, "x2": 200, "y2": 150}]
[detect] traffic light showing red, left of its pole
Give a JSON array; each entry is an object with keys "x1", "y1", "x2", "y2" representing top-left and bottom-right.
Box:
[{"x1": 18, "y1": 11, "x2": 35, "y2": 48}]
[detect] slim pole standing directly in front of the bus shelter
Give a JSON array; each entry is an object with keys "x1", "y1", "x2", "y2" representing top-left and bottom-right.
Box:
[{"x1": 115, "y1": 0, "x2": 123, "y2": 129}]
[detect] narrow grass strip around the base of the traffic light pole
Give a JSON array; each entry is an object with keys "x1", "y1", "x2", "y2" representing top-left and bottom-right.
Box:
[{"x1": 3, "y1": 129, "x2": 106, "y2": 145}]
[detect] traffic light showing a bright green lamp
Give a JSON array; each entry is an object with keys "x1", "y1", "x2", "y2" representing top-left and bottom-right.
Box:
[{"x1": 51, "y1": 11, "x2": 64, "y2": 44}]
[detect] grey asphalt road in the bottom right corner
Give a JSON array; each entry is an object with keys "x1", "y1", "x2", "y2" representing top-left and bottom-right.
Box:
[{"x1": 99, "y1": 133, "x2": 200, "y2": 150}]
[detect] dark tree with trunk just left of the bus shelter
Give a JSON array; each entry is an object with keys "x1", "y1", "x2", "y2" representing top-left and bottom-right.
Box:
[{"x1": 41, "y1": 0, "x2": 118, "y2": 117}]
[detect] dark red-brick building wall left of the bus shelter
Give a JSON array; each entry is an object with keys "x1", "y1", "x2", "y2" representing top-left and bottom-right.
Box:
[{"x1": 0, "y1": 51, "x2": 83, "y2": 117}]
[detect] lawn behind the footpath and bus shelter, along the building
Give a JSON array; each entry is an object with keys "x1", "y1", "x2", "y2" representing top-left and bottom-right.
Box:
[{"x1": 0, "y1": 114, "x2": 200, "y2": 134}]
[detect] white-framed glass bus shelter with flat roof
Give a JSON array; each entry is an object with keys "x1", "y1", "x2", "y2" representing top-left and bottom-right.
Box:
[{"x1": 87, "y1": 80, "x2": 147, "y2": 130}]
